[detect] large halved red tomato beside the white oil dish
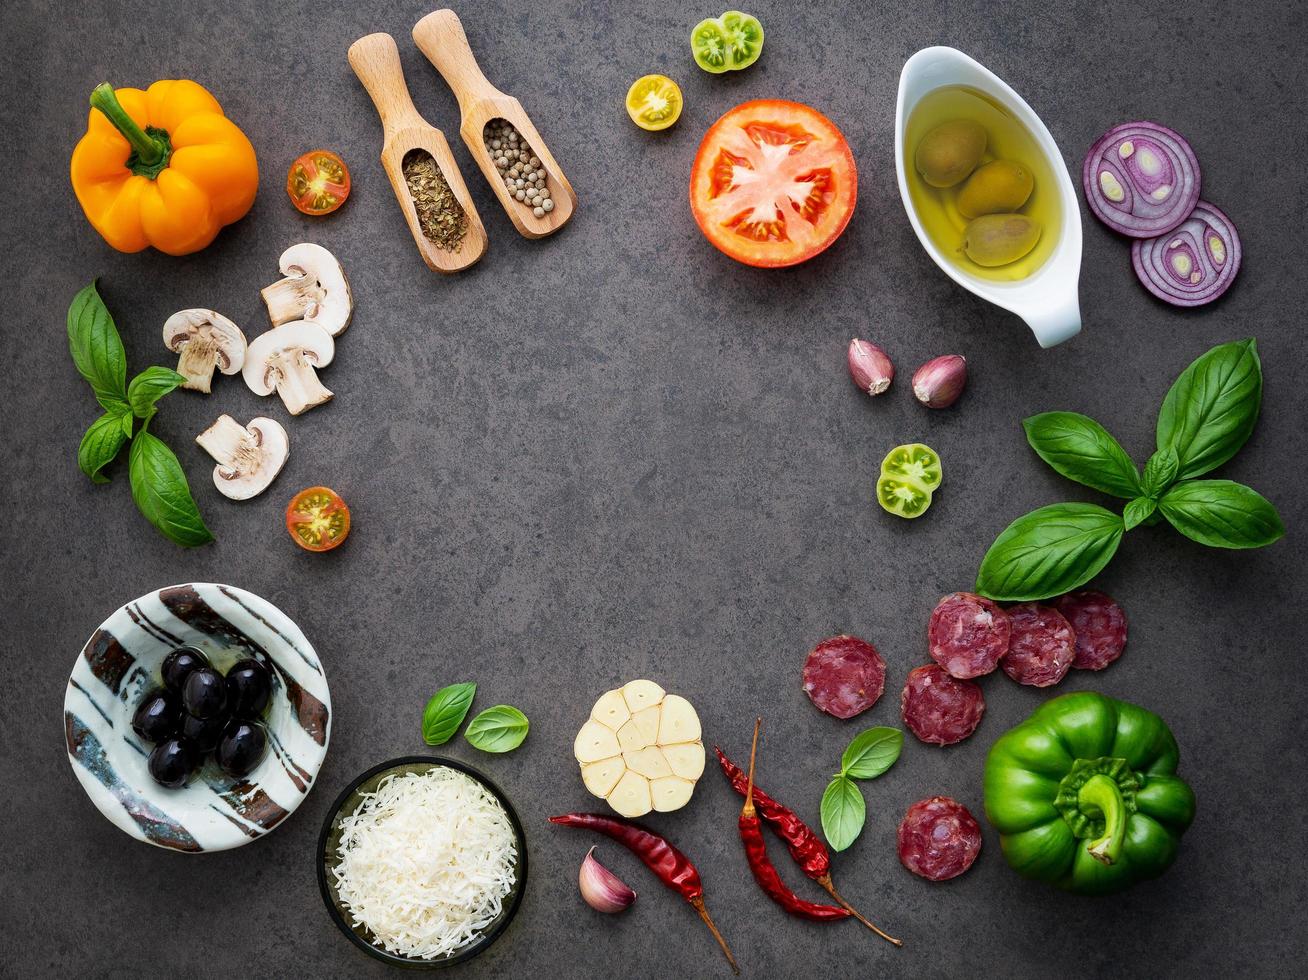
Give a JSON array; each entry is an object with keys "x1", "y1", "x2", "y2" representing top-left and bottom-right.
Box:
[{"x1": 691, "y1": 99, "x2": 858, "y2": 267}]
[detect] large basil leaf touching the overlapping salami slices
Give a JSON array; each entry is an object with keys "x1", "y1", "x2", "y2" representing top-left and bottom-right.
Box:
[{"x1": 977, "y1": 504, "x2": 1125, "y2": 602}]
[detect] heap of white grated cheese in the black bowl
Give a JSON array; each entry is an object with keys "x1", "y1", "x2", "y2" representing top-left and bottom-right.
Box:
[{"x1": 332, "y1": 765, "x2": 518, "y2": 959}]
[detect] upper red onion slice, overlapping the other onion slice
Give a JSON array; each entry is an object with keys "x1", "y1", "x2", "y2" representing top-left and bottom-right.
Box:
[{"x1": 1080, "y1": 120, "x2": 1199, "y2": 238}]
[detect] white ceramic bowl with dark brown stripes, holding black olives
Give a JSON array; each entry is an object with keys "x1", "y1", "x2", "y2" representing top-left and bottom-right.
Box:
[{"x1": 64, "y1": 584, "x2": 331, "y2": 852}]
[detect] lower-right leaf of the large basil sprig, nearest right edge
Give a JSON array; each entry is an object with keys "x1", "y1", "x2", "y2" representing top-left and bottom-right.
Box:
[{"x1": 1158, "y1": 480, "x2": 1286, "y2": 548}]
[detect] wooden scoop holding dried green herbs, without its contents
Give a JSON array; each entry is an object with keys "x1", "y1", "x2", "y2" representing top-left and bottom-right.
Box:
[{"x1": 349, "y1": 34, "x2": 487, "y2": 272}]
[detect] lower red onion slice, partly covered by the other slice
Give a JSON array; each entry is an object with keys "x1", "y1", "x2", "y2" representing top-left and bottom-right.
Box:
[{"x1": 1131, "y1": 200, "x2": 1240, "y2": 306}]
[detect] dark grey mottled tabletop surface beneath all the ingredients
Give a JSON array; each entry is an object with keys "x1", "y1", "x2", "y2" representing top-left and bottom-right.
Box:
[{"x1": 0, "y1": 0, "x2": 1308, "y2": 977}]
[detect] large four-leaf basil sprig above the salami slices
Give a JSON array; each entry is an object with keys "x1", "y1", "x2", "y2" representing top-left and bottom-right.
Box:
[{"x1": 976, "y1": 339, "x2": 1286, "y2": 602}]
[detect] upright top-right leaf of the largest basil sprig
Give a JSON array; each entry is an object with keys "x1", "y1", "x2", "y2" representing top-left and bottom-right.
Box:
[{"x1": 1158, "y1": 338, "x2": 1262, "y2": 480}]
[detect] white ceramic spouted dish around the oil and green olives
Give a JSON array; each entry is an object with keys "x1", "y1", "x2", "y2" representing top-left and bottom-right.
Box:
[{"x1": 895, "y1": 47, "x2": 1080, "y2": 347}]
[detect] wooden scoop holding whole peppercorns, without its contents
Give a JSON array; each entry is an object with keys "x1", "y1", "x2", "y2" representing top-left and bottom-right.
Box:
[{"x1": 413, "y1": 10, "x2": 577, "y2": 238}]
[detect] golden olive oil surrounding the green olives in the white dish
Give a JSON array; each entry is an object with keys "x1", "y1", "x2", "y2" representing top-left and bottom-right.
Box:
[{"x1": 904, "y1": 85, "x2": 1063, "y2": 283}]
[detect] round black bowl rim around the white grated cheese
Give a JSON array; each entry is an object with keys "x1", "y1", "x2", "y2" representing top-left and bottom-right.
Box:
[{"x1": 318, "y1": 755, "x2": 527, "y2": 970}]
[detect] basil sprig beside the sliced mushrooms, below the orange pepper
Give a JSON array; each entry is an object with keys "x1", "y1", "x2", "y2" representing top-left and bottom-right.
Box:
[{"x1": 68, "y1": 281, "x2": 213, "y2": 547}]
